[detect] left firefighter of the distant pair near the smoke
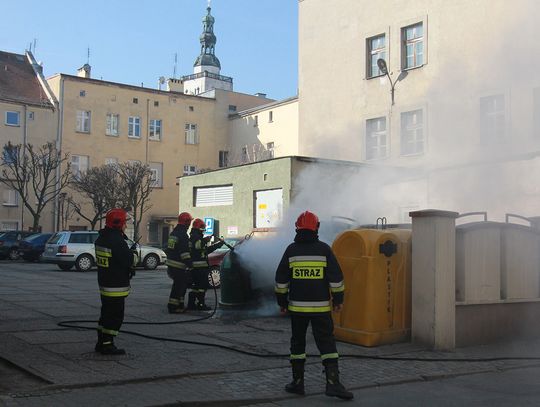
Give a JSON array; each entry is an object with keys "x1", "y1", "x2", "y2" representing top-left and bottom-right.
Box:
[{"x1": 165, "y1": 212, "x2": 193, "y2": 314}]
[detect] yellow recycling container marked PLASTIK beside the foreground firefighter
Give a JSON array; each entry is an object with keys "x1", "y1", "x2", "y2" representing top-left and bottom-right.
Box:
[{"x1": 332, "y1": 229, "x2": 411, "y2": 346}]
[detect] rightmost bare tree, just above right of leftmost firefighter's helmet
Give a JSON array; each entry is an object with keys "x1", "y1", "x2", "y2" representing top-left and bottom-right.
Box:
[{"x1": 116, "y1": 162, "x2": 155, "y2": 241}]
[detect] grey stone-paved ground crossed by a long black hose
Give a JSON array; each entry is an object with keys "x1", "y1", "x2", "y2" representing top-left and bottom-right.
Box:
[{"x1": 0, "y1": 262, "x2": 540, "y2": 406}]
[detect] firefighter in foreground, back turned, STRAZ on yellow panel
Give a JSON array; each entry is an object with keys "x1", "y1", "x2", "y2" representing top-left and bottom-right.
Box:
[{"x1": 275, "y1": 211, "x2": 353, "y2": 400}]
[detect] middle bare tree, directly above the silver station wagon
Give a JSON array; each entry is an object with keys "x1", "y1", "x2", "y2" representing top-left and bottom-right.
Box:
[{"x1": 68, "y1": 165, "x2": 123, "y2": 230}]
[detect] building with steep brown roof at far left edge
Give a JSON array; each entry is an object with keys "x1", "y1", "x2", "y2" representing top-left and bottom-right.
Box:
[{"x1": 0, "y1": 51, "x2": 58, "y2": 232}]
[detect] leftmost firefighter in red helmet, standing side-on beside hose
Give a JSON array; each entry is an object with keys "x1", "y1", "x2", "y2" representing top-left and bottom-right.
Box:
[{"x1": 95, "y1": 209, "x2": 137, "y2": 355}]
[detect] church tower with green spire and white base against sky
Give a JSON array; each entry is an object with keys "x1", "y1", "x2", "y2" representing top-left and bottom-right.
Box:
[{"x1": 182, "y1": 0, "x2": 233, "y2": 95}]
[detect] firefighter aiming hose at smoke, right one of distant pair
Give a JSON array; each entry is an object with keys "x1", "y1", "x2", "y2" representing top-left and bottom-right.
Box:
[{"x1": 187, "y1": 218, "x2": 224, "y2": 311}]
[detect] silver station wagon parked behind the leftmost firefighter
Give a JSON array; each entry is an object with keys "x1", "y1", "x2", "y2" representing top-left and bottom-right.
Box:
[{"x1": 41, "y1": 230, "x2": 167, "y2": 271}]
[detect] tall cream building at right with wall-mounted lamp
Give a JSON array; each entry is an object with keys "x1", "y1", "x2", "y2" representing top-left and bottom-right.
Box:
[{"x1": 298, "y1": 0, "x2": 540, "y2": 222}]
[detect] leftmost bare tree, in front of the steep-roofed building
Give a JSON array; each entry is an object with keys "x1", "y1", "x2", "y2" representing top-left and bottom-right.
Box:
[{"x1": 0, "y1": 142, "x2": 70, "y2": 231}]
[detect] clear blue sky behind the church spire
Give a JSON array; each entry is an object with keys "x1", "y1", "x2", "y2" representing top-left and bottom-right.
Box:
[{"x1": 0, "y1": 0, "x2": 298, "y2": 100}]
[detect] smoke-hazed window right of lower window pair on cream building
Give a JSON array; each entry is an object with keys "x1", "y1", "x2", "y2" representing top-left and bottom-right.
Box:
[{"x1": 480, "y1": 95, "x2": 506, "y2": 142}]
